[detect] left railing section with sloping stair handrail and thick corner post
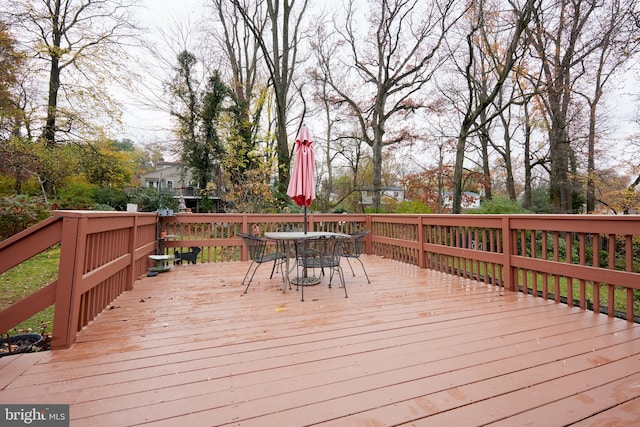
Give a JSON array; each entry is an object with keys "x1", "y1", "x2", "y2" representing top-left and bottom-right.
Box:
[{"x1": 0, "y1": 211, "x2": 157, "y2": 348}]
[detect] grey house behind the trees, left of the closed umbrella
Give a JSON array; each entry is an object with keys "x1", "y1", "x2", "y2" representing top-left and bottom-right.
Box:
[{"x1": 140, "y1": 160, "x2": 224, "y2": 212}]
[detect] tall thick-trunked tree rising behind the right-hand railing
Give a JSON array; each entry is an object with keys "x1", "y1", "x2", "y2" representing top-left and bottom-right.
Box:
[{"x1": 531, "y1": 0, "x2": 632, "y2": 213}]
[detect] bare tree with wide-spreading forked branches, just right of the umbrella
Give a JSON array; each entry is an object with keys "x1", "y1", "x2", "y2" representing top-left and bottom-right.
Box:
[{"x1": 320, "y1": 0, "x2": 453, "y2": 211}]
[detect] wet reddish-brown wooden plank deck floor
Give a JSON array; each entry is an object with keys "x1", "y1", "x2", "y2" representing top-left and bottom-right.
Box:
[{"x1": 0, "y1": 256, "x2": 640, "y2": 427}]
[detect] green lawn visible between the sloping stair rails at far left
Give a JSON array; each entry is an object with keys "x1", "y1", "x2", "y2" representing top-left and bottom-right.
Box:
[{"x1": 0, "y1": 246, "x2": 60, "y2": 335}]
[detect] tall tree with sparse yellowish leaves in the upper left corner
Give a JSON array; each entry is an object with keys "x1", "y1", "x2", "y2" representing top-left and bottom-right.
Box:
[{"x1": 8, "y1": 0, "x2": 136, "y2": 147}]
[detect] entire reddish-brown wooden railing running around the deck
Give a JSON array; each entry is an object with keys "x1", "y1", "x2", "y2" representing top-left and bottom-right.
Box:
[{"x1": 0, "y1": 211, "x2": 640, "y2": 348}]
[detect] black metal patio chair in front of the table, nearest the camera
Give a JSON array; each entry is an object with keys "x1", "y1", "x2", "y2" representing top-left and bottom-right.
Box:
[{"x1": 296, "y1": 237, "x2": 348, "y2": 301}]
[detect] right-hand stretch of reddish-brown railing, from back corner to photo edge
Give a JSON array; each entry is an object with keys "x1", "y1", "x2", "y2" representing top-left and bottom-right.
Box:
[{"x1": 371, "y1": 215, "x2": 640, "y2": 321}]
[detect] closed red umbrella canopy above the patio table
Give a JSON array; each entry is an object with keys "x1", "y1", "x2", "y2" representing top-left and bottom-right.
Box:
[{"x1": 287, "y1": 125, "x2": 316, "y2": 206}]
